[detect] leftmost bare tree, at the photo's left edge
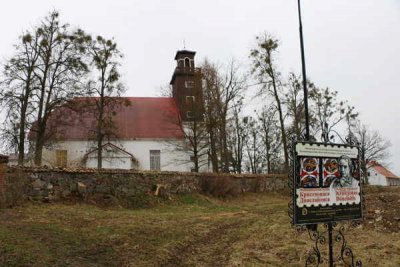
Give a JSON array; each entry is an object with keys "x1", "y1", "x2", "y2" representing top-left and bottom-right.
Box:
[{"x1": 0, "y1": 32, "x2": 39, "y2": 165}]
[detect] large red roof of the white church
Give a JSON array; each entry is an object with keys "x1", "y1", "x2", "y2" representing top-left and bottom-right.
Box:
[{"x1": 29, "y1": 97, "x2": 184, "y2": 140}]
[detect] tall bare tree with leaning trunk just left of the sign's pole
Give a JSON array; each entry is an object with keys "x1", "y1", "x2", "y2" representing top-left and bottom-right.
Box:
[{"x1": 250, "y1": 33, "x2": 289, "y2": 170}]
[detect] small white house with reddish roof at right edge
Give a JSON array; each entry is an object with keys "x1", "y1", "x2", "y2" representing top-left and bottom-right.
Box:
[{"x1": 367, "y1": 162, "x2": 400, "y2": 186}]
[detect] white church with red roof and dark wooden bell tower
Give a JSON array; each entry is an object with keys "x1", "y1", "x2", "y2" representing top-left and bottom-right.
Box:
[{"x1": 29, "y1": 50, "x2": 209, "y2": 171}]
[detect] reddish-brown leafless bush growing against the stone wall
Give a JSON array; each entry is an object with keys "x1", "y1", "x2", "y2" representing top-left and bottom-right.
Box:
[{"x1": 201, "y1": 176, "x2": 240, "y2": 198}]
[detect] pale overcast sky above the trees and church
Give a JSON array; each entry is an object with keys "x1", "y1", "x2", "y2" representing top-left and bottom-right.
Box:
[{"x1": 0, "y1": 0, "x2": 400, "y2": 175}]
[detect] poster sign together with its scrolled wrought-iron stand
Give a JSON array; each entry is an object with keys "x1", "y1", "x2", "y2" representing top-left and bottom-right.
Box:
[{"x1": 289, "y1": 140, "x2": 364, "y2": 267}]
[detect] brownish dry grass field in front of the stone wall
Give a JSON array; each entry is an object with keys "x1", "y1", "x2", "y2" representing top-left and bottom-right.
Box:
[{"x1": 0, "y1": 188, "x2": 400, "y2": 267}]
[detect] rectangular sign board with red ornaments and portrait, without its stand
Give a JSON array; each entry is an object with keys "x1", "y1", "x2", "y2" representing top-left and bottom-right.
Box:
[{"x1": 292, "y1": 142, "x2": 362, "y2": 225}]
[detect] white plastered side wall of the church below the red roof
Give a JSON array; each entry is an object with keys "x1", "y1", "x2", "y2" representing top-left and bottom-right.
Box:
[{"x1": 43, "y1": 139, "x2": 208, "y2": 172}]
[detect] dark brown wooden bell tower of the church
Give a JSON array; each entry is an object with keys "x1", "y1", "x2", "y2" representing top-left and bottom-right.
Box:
[{"x1": 170, "y1": 50, "x2": 204, "y2": 122}]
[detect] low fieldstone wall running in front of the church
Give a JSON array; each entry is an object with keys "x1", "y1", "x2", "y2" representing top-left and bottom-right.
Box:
[{"x1": 3, "y1": 167, "x2": 287, "y2": 207}]
